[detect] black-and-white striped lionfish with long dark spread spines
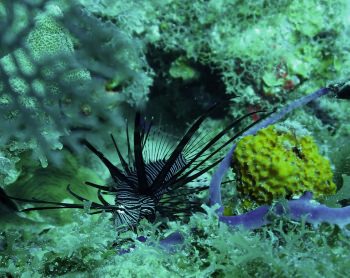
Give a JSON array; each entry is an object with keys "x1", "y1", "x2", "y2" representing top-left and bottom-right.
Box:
[{"x1": 10, "y1": 101, "x2": 265, "y2": 229}]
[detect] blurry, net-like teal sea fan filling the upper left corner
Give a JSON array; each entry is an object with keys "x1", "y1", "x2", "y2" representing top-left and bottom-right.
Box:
[{"x1": 0, "y1": 1, "x2": 151, "y2": 165}]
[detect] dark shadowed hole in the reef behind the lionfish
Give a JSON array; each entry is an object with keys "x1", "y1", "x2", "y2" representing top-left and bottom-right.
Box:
[{"x1": 145, "y1": 48, "x2": 228, "y2": 132}]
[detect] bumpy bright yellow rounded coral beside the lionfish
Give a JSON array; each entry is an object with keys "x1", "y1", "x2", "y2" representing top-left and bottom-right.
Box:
[{"x1": 233, "y1": 126, "x2": 336, "y2": 204}]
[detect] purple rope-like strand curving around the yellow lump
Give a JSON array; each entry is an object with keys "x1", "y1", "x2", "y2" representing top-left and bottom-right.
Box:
[{"x1": 209, "y1": 88, "x2": 350, "y2": 229}]
